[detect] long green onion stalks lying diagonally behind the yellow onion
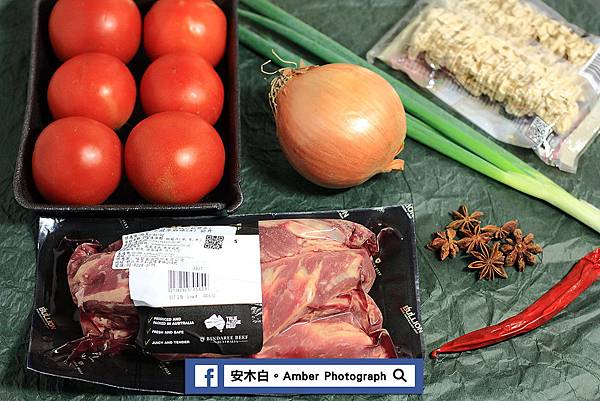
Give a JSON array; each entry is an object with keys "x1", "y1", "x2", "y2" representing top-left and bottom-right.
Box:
[{"x1": 239, "y1": 20, "x2": 600, "y2": 233}]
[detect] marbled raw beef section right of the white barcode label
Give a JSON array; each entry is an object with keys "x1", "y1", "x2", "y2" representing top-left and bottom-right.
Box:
[{"x1": 256, "y1": 220, "x2": 395, "y2": 358}]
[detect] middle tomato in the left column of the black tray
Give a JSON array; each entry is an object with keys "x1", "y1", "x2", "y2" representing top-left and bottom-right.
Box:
[{"x1": 48, "y1": 53, "x2": 136, "y2": 129}]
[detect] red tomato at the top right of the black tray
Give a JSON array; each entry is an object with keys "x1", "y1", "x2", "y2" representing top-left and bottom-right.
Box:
[{"x1": 144, "y1": 0, "x2": 227, "y2": 66}]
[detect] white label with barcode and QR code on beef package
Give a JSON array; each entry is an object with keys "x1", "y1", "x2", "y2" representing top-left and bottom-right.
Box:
[{"x1": 112, "y1": 226, "x2": 262, "y2": 307}]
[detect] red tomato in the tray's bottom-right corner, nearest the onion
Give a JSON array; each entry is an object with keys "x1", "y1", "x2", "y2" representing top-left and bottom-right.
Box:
[{"x1": 125, "y1": 111, "x2": 225, "y2": 204}]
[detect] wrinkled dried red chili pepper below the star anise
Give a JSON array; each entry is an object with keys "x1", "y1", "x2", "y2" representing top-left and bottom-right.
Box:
[{"x1": 431, "y1": 248, "x2": 600, "y2": 358}]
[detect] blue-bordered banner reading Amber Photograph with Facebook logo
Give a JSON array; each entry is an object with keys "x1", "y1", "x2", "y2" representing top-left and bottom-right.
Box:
[{"x1": 185, "y1": 359, "x2": 423, "y2": 394}]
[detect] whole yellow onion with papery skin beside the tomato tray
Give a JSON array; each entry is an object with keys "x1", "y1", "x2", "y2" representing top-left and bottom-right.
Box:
[{"x1": 270, "y1": 64, "x2": 406, "y2": 188}]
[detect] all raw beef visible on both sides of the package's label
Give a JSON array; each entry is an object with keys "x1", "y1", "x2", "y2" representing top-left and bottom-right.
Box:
[{"x1": 67, "y1": 219, "x2": 395, "y2": 358}]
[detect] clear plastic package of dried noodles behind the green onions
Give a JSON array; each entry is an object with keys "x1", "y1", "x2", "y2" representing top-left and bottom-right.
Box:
[{"x1": 368, "y1": 0, "x2": 600, "y2": 173}]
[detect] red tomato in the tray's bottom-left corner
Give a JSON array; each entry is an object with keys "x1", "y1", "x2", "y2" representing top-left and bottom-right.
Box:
[{"x1": 32, "y1": 117, "x2": 123, "y2": 205}]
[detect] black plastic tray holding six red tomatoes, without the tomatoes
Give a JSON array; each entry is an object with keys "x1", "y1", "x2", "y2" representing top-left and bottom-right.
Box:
[{"x1": 13, "y1": 0, "x2": 243, "y2": 216}]
